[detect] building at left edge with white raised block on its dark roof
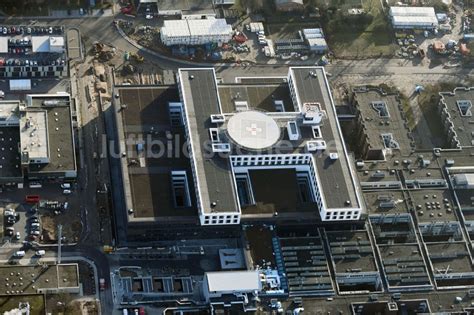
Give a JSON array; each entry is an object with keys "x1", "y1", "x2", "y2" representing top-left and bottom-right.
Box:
[{"x1": 0, "y1": 93, "x2": 77, "y2": 184}]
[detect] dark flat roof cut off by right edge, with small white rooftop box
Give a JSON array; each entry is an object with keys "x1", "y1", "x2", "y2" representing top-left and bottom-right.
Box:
[{"x1": 440, "y1": 88, "x2": 474, "y2": 147}]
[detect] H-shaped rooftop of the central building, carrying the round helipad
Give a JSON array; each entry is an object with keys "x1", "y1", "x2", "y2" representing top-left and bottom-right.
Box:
[{"x1": 179, "y1": 67, "x2": 361, "y2": 219}]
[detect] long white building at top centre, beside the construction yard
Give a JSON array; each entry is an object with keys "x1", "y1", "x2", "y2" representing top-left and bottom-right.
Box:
[{"x1": 161, "y1": 18, "x2": 233, "y2": 46}]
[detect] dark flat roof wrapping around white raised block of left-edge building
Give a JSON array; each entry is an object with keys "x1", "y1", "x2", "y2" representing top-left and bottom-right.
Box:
[{"x1": 20, "y1": 94, "x2": 76, "y2": 173}]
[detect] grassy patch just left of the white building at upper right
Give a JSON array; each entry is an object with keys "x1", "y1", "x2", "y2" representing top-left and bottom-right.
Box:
[{"x1": 326, "y1": 0, "x2": 397, "y2": 58}]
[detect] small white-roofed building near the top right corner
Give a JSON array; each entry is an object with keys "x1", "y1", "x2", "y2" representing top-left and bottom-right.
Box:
[{"x1": 390, "y1": 7, "x2": 438, "y2": 29}]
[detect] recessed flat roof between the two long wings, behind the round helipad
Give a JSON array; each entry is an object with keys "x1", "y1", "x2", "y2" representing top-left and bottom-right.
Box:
[{"x1": 218, "y1": 83, "x2": 295, "y2": 113}]
